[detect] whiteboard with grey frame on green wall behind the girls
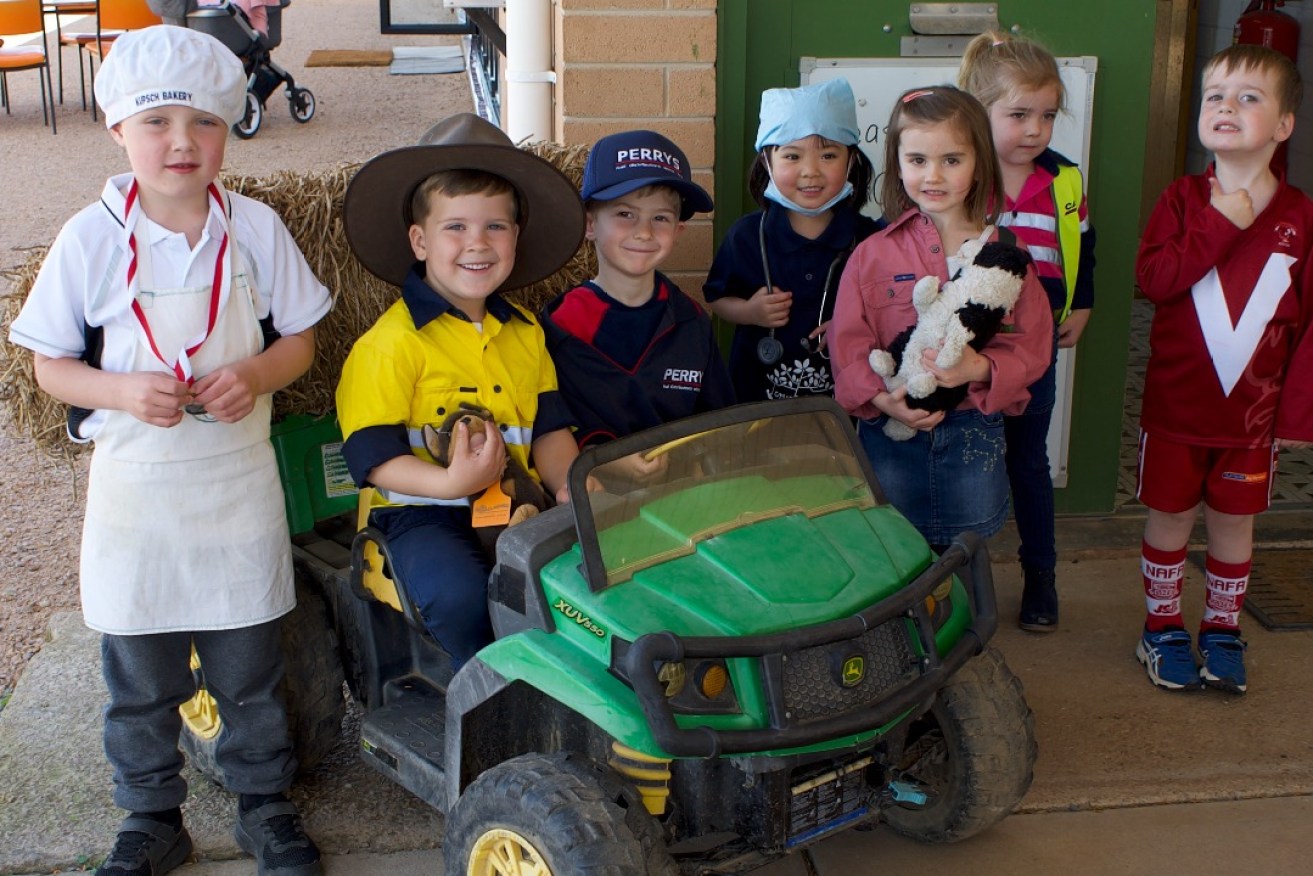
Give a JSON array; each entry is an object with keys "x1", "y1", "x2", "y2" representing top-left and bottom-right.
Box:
[{"x1": 798, "y1": 55, "x2": 1099, "y2": 487}]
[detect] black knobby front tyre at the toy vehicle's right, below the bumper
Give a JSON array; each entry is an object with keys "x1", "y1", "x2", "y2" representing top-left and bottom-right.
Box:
[{"x1": 884, "y1": 647, "x2": 1037, "y2": 843}]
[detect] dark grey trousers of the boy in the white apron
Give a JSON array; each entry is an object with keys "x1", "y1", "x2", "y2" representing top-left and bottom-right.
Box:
[{"x1": 101, "y1": 620, "x2": 297, "y2": 812}]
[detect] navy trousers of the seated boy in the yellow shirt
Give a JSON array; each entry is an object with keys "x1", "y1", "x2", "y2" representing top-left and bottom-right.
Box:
[{"x1": 372, "y1": 506, "x2": 492, "y2": 668}]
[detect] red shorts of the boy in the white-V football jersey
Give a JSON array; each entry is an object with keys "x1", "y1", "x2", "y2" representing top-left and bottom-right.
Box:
[{"x1": 1136, "y1": 429, "x2": 1276, "y2": 515}]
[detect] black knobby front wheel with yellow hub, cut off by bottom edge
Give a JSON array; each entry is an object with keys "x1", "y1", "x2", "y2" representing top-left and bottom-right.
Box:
[{"x1": 442, "y1": 754, "x2": 679, "y2": 876}]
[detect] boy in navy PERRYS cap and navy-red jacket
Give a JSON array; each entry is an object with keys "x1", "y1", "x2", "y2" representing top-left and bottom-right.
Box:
[{"x1": 542, "y1": 131, "x2": 734, "y2": 465}]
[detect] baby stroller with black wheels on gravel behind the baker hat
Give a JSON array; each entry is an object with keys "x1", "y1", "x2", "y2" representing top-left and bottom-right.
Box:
[{"x1": 186, "y1": 0, "x2": 315, "y2": 141}]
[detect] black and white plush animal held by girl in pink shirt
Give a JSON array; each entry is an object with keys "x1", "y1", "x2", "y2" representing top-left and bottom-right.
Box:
[{"x1": 869, "y1": 240, "x2": 1031, "y2": 441}]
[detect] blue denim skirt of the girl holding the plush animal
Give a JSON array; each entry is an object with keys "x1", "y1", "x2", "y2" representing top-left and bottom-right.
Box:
[{"x1": 857, "y1": 410, "x2": 1007, "y2": 545}]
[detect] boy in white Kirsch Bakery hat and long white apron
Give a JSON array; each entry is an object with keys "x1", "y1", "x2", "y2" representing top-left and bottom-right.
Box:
[{"x1": 9, "y1": 25, "x2": 330, "y2": 876}]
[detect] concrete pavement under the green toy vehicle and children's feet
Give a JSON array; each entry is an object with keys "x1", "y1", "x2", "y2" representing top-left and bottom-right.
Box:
[{"x1": 0, "y1": 512, "x2": 1313, "y2": 876}]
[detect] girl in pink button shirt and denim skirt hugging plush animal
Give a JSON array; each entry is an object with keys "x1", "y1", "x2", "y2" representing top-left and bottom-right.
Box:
[{"x1": 830, "y1": 85, "x2": 1053, "y2": 552}]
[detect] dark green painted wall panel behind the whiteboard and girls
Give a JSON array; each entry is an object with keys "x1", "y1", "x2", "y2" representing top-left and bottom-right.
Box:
[{"x1": 716, "y1": 0, "x2": 1158, "y2": 514}]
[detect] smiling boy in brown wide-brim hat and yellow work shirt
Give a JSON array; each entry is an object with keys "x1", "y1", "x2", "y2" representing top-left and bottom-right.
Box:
[{"x1": 337, "y1": 113, "x2": 584, "y2": 667}]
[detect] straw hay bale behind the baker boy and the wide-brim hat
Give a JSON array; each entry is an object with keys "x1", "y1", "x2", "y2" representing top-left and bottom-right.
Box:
[{"x1": 0, "y1": 143, "x2": 597, "y2": 458}]
